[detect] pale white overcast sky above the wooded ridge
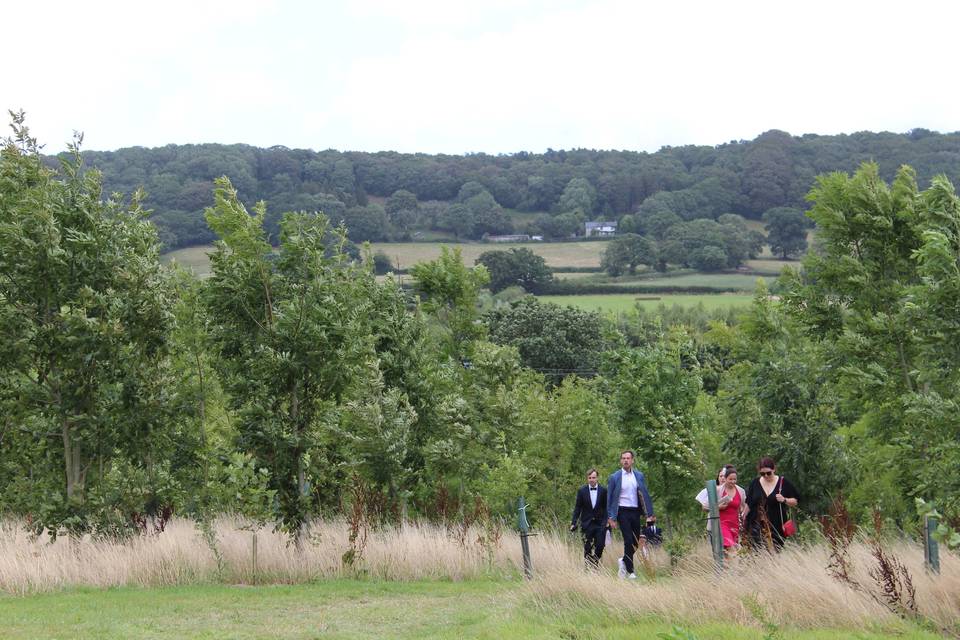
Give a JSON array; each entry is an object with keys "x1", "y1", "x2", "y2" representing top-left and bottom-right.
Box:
[{"x1": 0, "y1": 0, "x2": 960, "y2": 153}]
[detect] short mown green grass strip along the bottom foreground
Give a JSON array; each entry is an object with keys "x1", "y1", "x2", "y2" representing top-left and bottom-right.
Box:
[{"x1": 0, "y1": 580, "x2": 938, "y2": 640}]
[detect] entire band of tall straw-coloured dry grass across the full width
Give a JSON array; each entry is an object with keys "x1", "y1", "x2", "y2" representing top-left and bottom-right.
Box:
[{"x1": 0, "y1": 519, "x2": 960, "y2": 630}]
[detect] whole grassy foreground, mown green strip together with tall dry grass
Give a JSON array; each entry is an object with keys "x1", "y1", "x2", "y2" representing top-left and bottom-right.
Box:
[{"x1": 0, "y1": 519, "x2": 960, "y2": 640}]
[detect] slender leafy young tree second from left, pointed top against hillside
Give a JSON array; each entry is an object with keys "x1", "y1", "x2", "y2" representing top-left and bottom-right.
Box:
[{"x1": 206, "y1": 178, "x2": 375, "y2": 533}]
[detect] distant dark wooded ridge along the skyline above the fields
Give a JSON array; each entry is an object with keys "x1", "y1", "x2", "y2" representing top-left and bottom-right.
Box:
[{"x1": 73, "y1": 129, "x2": 960, "y2": 249}]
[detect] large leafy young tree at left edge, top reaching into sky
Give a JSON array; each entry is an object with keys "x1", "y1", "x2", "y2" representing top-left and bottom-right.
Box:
[{"x1": 0, "y1": 112, "x2": 172, "y2": 535}]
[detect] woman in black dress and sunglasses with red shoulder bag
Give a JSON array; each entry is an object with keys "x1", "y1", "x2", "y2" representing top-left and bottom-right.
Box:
[{"x1": 745, "y1": 457, "x2": 800, "y2": 551}]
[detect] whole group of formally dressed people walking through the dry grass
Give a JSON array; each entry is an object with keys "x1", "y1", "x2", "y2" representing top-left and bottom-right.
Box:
[{"x1": 570, "y1": 449, "x2": 800, "y2": 579}]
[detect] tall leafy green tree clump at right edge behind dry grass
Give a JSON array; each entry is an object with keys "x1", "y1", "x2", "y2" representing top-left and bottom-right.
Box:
[{"x1": 784, "y1": 164, "x2": 960, "y2": 515}]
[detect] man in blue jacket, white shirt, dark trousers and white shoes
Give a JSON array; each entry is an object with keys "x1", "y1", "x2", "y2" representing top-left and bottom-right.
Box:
[{"x1": 607, "y1": 449, "x2": 657, "y2": 580}]
